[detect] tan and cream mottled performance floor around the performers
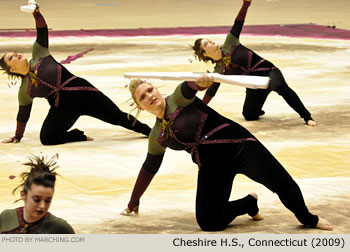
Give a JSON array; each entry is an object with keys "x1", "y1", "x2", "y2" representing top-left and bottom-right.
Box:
[{"x1": 0, "y1": 0, "x2": 350, "y2": 234}]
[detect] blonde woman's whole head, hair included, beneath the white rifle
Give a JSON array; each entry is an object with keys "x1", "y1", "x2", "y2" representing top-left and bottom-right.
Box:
[{"x1": 129, "y1": 79, "x2": 165, "y2": 117}]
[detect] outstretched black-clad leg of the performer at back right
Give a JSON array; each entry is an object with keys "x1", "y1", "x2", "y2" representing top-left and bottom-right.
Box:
[{"x1": 269, "y1": 69, "x2": 312, "y2": 123}]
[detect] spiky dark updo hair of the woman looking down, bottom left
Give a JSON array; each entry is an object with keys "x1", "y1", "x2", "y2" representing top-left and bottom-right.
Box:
[{"x1": 12, "y1": 154, "x2": 58, "y2": 199}]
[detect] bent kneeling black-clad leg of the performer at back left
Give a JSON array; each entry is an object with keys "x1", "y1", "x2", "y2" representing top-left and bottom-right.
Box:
[{"x1": 40, "y1": 107, "x2": 86, "y2": 145}]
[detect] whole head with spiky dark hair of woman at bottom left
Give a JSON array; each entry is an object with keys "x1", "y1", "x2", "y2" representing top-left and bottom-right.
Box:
[{"x1": 13, "y1": 155, "x2": 57, "y2": 223}]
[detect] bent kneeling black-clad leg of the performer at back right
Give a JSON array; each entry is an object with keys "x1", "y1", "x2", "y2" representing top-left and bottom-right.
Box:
[{"x1": 242, "y1": 88, "x2": 270, "y2": 121}]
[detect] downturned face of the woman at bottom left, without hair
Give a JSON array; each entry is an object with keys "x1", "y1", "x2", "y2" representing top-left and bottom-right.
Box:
[{"x1": 21, "y1": 184, "x2": 54, "y2": 223}]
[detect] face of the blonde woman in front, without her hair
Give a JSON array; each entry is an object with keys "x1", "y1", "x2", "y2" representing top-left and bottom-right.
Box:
[{"x1": 135, "y1": 83, "x2": 165, "y2": 117}]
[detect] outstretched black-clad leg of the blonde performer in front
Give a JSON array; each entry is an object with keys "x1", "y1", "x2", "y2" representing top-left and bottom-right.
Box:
[{"x1": 236, "y1": 142, "x2": 318, "y2": 227}]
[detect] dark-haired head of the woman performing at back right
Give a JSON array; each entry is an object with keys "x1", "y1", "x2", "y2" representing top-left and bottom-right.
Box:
[{"x1": 192, "y1": 38, "x2": 220, "y2": 63}]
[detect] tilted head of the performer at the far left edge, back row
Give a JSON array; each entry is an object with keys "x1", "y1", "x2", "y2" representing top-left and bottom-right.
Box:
[{"x1": 0, "y1": 52, "x2": 30, "y2": 78}]
